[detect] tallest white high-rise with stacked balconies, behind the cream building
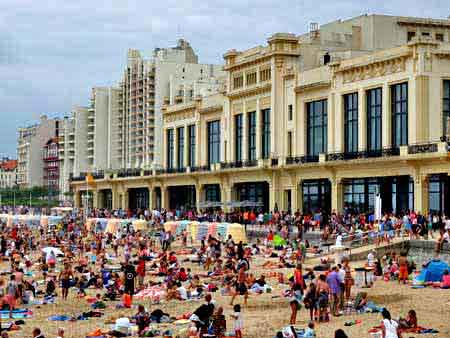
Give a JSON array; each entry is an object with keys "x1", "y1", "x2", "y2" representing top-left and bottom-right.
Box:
[{"x1": 119, "y1": 39, "x2": 224, "y2": 168}]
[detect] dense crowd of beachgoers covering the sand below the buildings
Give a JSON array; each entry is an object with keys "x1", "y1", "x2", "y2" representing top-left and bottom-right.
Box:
[{"x1": 0, "y1": 203, "x2": 444, "y2": 338}]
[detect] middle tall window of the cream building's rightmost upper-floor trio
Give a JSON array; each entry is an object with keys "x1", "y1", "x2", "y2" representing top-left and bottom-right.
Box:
[{"x1": 366, "y1": 88, "x2": 382, "y2": 151}]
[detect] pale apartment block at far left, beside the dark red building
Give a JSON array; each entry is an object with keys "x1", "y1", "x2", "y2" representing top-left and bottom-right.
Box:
[{"x1": 17, "y1": 115, "x2": 60, "y2": 188}]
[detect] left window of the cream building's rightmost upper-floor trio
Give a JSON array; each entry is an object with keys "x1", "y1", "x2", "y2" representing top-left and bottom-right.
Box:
[{"x1": 344, "y1": 93, "x2": 358, "y2": 153}]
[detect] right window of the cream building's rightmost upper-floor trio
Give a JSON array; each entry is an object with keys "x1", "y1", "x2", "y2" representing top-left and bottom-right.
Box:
[{"x1": 391, "y1": 82, "x2": 408, "y2": 147}]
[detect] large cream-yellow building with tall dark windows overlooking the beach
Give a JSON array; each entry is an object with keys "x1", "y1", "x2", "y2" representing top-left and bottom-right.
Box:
[{"x1": 72, "y1": 15, "x2": 450, "y2": 213}]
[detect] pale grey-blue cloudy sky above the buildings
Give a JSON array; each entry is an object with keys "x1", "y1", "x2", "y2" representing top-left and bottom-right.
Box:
[{"x1": 0, "y1": 0, "x2": 450, "y2": 157}]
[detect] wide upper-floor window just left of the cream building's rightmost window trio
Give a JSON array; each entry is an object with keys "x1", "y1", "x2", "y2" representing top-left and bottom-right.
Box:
[{"x1": 307, "y1": 100, "x2": 328, "y2": 156}]
